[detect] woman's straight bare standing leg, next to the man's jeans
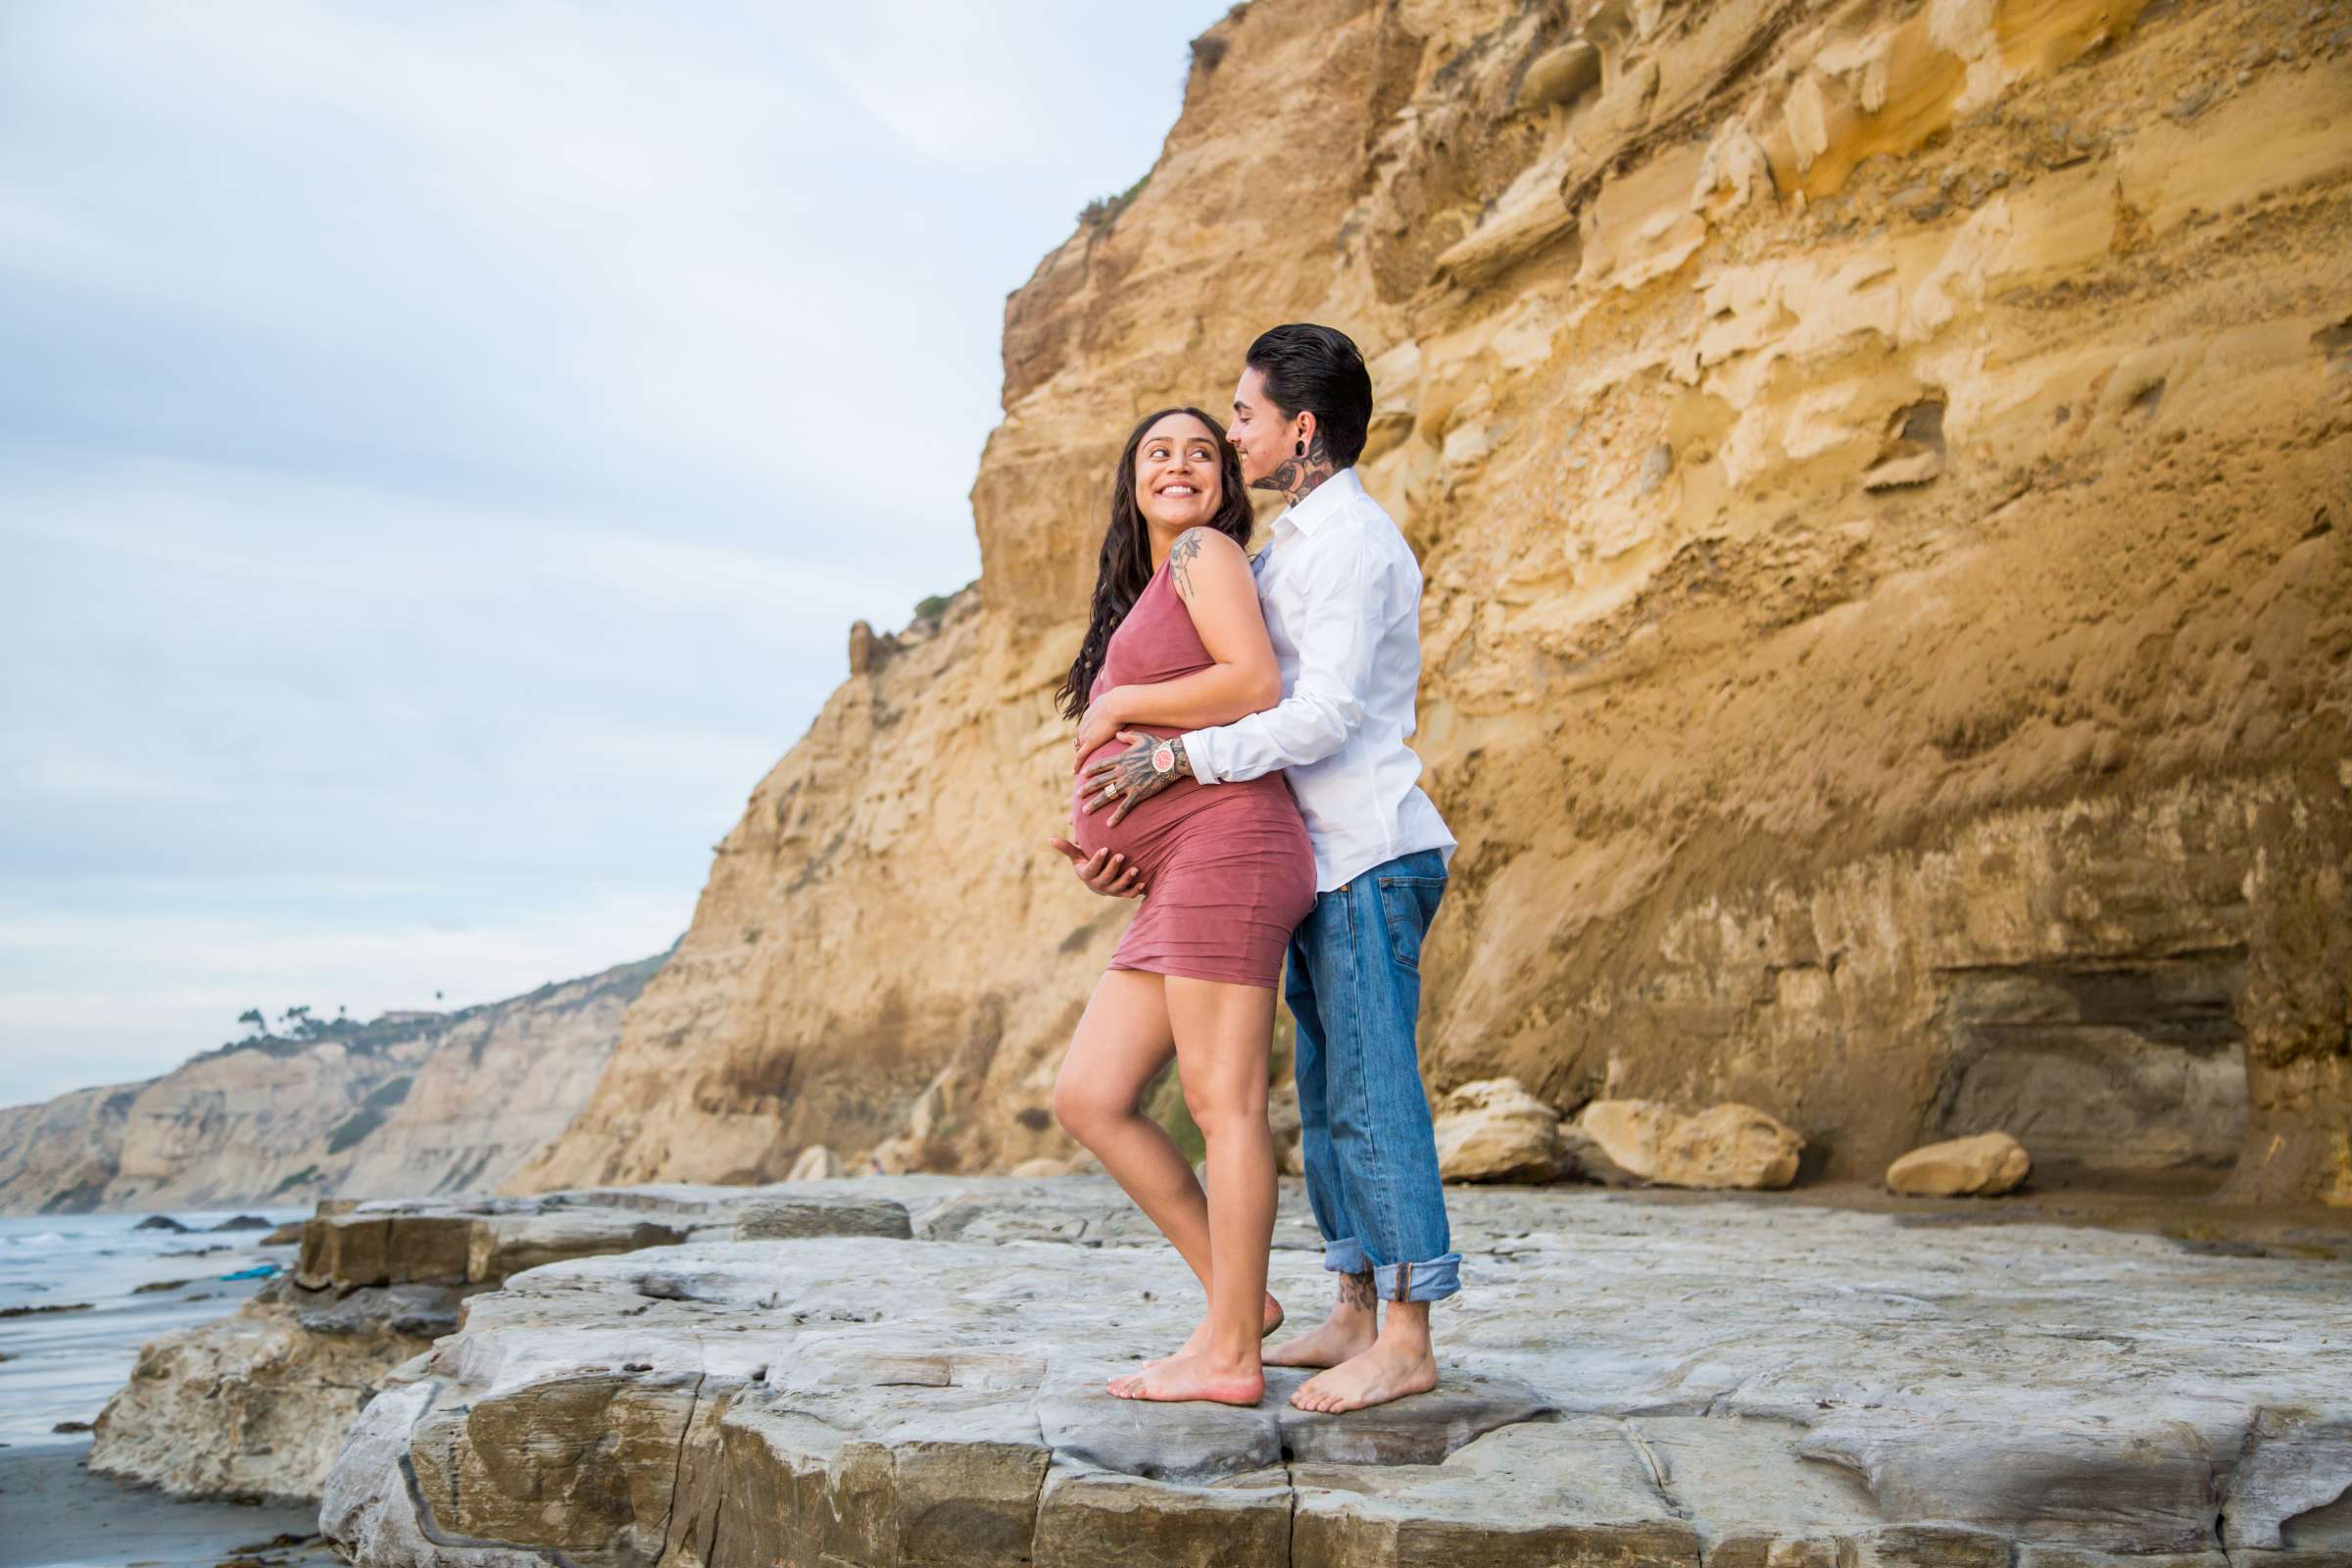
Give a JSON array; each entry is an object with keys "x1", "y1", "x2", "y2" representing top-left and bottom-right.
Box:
[{"x1": 1110, "y1": 976, "x2": 1275, "y2": 1403}]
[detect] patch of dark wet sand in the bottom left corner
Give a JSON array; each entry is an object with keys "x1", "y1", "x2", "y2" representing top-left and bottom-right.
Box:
[{"x1": 0, "y1": 1437, "x2": 339, "y2": 1568}]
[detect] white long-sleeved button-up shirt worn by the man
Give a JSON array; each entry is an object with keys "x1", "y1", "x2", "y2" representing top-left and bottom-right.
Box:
[{"x1": 1183, "y1": 467, "x2": 1453, "y2": 894}]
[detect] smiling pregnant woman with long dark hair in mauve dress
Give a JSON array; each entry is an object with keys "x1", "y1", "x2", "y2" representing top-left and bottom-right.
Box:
[{"x1": 1054, "y1": 409, "x2": 1315, "y2": 1403}]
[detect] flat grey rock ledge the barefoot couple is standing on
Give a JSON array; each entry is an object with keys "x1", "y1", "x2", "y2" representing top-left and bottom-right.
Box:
[{"x1": 319, "y1": 1178, "x2": 2352, "y2": 1568}]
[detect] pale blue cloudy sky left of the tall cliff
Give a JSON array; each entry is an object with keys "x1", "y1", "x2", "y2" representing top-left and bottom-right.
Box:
[{"x1": 0, "y1": 0, "x2": 1225, "y2": 1104}]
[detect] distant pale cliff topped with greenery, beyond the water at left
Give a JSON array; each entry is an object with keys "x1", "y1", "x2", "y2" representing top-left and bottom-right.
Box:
[{"x1": 0, "y1": 955, "x2": 668, "y2": 1213}]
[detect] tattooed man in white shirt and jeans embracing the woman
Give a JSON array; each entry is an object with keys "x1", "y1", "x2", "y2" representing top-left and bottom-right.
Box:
[{"x1": 1070, "y1": 324, "x2": 1460, "y2": 1410}]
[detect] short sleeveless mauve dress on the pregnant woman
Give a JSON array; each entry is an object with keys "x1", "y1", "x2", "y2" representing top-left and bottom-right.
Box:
[{"x1": 1070, "y1": 566, "x2": 1315, "y2": 987}]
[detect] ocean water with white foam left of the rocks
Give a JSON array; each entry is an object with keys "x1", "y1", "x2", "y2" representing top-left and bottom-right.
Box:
[{"x1": 0, "y1": 1206, "x2": 311, "y2": 1444}]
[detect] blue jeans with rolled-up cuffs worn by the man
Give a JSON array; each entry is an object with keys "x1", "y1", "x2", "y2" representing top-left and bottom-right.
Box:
[{"x1": 1282, "y1": 849, "x2": 1463, "y2": 1302}]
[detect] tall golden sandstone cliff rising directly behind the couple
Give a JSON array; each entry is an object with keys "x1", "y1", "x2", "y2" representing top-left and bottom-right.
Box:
[{"x1": 515, "y1": 0, "x2": 2352, "y2": 1201}]
